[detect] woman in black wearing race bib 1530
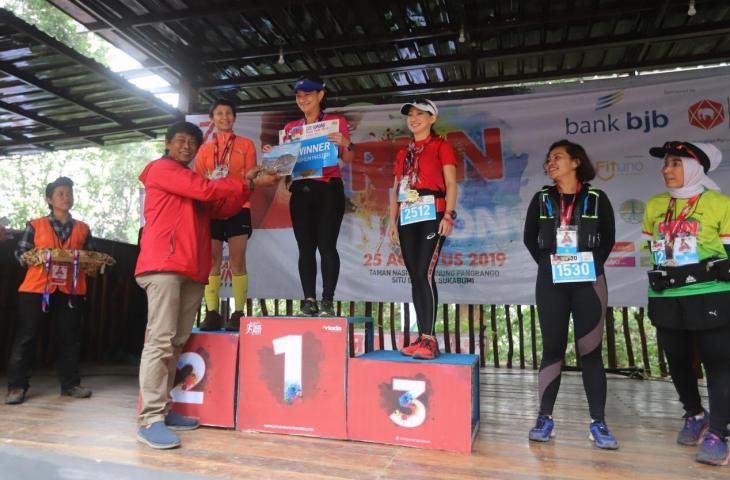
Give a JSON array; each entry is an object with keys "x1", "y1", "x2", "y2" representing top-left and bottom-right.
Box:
[{"x1": 524, "y1": 140, "x2": 618, "y2": 450}]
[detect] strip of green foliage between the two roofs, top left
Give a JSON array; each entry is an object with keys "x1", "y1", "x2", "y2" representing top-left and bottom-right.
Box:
[{"x1": 0, "y1": 0, "x2": 110, "y2": 66}]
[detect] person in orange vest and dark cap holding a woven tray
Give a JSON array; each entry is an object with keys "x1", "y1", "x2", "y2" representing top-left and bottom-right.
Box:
[{"x1": 5, "y1": 177, "x2": 94, "y2": 405}]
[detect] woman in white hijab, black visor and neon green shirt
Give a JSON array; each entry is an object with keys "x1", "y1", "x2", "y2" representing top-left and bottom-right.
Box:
[{"x1": 642, "y1": 141, "x2": 730, "y2": 465}]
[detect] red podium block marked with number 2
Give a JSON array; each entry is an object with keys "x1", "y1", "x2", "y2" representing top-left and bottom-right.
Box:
[{"x1": 170, "y1": 329, "x2": 238, "y2": 428}]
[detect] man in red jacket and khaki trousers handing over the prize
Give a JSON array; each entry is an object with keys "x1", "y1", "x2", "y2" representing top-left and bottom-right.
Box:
[{"x1": 135, "y1": 122, "x2": 278, "y2": 449}]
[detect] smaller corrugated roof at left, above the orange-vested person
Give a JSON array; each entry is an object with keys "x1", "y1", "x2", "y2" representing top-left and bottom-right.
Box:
[{"x1": 0, "y1": 9, "x2": 182, "y2": 155}]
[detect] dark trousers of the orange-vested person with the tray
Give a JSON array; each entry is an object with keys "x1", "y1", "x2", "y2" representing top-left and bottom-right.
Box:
[{"x1": 8, "y1": 291, "x2": 84, "y2": 390}]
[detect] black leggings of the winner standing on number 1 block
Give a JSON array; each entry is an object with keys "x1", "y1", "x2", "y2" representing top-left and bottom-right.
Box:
[{"x1": 289, "y1": 178, "x2": 345, "y2": 301}]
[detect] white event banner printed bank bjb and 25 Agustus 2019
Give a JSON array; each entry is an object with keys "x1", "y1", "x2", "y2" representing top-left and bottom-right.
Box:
[{"x1": 189, "y1": 69, "x2": 730, "y2": 306}]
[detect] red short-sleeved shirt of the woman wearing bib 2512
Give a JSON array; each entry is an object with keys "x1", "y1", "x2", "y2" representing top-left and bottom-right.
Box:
[{"x1": 393, "y1": 137, "x2": 456, "y2": 193}]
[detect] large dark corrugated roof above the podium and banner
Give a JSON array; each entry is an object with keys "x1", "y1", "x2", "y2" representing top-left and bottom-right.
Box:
[{"x1": 44, "y1": 0, "x2": 730, "y2": 111}]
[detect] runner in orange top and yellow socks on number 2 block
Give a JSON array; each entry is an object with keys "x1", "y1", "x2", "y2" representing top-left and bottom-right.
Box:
[{"x1": 194, "y1": 99, "x2": 256, "y2": 331}]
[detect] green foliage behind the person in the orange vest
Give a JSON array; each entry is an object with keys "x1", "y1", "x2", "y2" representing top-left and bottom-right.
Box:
[{"x1": 0, "y1": 142, "x2": 163, "y2": 243}]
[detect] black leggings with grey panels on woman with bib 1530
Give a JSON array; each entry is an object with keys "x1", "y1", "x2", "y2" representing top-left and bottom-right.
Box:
[{"x1": 535, "y1": 263, "x2": 608, "y2": 421}]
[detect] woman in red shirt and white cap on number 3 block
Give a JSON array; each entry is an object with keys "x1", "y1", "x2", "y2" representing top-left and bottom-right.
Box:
[{"x1": 388, "y1": 99, "x2": 457, "y2": 360}]
